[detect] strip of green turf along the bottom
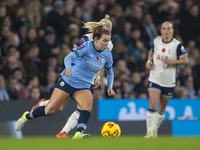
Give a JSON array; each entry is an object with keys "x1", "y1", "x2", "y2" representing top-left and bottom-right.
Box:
[{"x1": 0, "y1": 136, "x2": 200, "y2": 150}]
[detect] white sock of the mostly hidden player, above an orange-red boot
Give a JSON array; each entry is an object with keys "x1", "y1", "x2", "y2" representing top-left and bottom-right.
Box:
[{"x1": 60, "y1": 110, "x2": 81, "y2": 133}]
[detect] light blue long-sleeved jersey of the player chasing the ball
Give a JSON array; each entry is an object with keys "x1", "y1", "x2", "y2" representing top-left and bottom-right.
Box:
[{"x1": 61, "y1": 41, "x2": 114, "y2": 89}]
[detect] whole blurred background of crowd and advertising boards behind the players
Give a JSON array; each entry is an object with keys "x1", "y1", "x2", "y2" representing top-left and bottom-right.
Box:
[{"x1": 0, "y1": 0, "x2": 200, "y2": 138}]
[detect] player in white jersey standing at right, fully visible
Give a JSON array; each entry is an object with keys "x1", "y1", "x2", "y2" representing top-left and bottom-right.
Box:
[{"x1": 145, "y1": 22, "x2": 188, "y2": 138}]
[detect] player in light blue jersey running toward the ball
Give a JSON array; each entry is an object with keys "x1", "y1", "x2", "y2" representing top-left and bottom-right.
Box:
[{"x1": 15, "y1": 23, "x2": 115, "y2": 139}]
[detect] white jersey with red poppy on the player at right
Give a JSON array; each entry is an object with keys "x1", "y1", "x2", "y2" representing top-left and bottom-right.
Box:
[{"x1": 149, "y1": 37, "x2": 188, "y2": 87}]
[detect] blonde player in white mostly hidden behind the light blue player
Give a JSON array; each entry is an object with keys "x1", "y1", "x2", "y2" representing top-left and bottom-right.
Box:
[{"x1": 28, "y1": 15, "x2": 113, "y2": 138}]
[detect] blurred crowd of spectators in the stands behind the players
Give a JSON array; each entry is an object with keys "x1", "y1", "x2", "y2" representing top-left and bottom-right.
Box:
[{"x1": 0, "y1": 0, "x2": 200, "y2": 100}]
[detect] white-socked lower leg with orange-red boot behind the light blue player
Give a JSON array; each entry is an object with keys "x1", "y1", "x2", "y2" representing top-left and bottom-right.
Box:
[{"x1": 56, "y1": 109, "x2": 81, "y2": 138}]
